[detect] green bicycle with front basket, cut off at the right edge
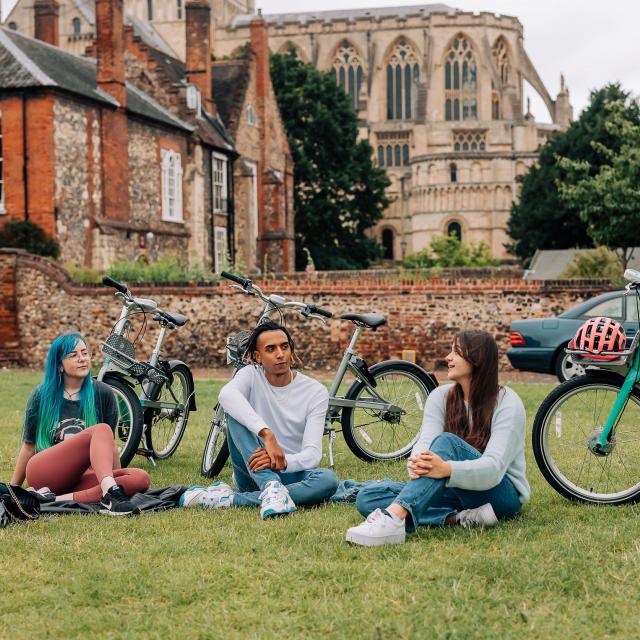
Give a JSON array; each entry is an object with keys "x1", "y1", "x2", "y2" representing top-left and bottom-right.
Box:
[{"x1": 532, "y1": 269, "x2": 640, "y2": 505}]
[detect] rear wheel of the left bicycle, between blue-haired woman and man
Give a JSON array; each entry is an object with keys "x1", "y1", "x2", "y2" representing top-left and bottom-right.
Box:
[{"x1": 144, "y1": 363, "x2": 193, "y2": 460}]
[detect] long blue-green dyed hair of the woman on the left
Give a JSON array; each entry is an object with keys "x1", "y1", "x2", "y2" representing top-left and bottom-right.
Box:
[{"x1": 36, "y1": 332, "x2": 98, "y2": 451}]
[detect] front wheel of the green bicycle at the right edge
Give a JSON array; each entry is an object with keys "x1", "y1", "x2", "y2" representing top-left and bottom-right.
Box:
[{"x1": 532, "y1": 371, "x2": 640, "y2": 505}]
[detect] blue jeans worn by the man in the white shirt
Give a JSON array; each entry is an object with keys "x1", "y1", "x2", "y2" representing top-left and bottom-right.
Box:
[{"x1": 227, "y1": 414, "x2": 338, "y2": 507}]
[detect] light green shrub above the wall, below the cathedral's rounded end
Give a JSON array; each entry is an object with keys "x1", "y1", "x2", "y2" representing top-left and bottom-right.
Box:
[{"x1": 402, "y1": 234, "x2": 500, "y2": 269}]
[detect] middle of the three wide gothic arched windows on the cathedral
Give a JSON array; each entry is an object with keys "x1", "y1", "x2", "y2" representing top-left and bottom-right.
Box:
[{"x1": 387, "y1": 38, "x2": 420, "y2": 120}]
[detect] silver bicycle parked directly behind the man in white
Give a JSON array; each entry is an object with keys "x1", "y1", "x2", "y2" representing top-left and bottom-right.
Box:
[{"x1": 200, "y1": 272, "x2": 437, "y2": 478}]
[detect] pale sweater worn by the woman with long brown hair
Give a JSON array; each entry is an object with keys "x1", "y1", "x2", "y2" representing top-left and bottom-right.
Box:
[{"x1": 411, "y1": 384, "x2": 531, "y2": 503}]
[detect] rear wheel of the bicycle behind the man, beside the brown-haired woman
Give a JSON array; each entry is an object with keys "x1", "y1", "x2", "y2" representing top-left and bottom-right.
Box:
[{"x1": 341, "y1": 360, "x2": 436, "y2": 462}]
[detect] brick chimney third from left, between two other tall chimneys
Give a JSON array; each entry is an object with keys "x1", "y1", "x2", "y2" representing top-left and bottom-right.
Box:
[{"x1": 185, "y1": 0, "x2": 214, "y2": 111}]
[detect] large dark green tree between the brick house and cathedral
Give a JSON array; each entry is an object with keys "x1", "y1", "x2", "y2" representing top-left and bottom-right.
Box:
[{"x1": 271, "y1": 52, "x2": 390, "y2": 269}]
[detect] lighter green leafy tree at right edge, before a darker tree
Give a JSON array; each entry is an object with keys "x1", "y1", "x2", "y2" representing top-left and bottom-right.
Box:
[{"x1": 558, "y1": 100, "x2": 640, "y2": 269}]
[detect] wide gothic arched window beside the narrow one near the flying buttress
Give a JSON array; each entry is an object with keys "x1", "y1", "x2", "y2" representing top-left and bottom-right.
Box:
[{"x1": 444, "y1": 33, "x2": 478, "y2": 120}]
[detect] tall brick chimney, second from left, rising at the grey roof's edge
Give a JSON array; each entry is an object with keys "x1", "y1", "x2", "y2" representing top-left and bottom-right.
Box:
[{"x1": 96, "y1": 0, "x2": 127, "y2": 107}]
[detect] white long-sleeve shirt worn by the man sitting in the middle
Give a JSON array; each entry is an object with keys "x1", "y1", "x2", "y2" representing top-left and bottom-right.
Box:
[{"x1": 218, "y1": 366, "x2": 329, "y2": 473}]
